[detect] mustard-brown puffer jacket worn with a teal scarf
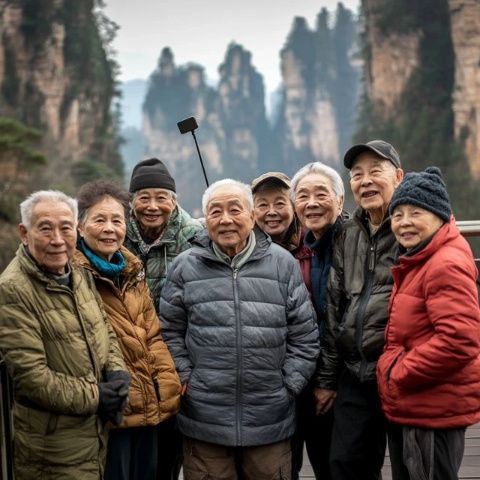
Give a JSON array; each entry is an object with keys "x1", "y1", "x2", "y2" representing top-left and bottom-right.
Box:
[{"x1": 75, "y1": 248, "x2": 180, "y2": 427}]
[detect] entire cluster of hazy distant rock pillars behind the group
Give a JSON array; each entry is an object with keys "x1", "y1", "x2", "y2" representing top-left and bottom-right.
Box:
[{"x1": 143, "y1": 4, "x2": 360, "y2": 204}]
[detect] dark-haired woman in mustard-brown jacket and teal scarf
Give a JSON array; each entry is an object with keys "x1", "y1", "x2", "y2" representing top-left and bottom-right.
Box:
[{"x1": 75, "y1": 181, "x2": 180, "y2": 480}]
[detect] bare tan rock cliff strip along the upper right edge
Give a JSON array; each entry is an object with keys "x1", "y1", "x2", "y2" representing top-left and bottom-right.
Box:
[{"x1": 449, "y1": 0, "x2": 480, "y2": 180}]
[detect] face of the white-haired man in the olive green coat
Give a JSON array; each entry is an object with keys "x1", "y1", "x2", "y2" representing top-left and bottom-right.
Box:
[{"x1": 19, "y1": 200, "x2": 77, "y2": 275}]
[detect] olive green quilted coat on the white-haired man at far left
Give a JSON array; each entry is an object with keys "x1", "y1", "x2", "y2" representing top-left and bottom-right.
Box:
[{"x1": 0, "y1": 246, "x2": 125, "y2": 480}]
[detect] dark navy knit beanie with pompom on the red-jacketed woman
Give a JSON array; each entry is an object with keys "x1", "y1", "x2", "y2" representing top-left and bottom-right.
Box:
[{"x1": 390, "y1": 167, "x2": 452, "y2": 222}]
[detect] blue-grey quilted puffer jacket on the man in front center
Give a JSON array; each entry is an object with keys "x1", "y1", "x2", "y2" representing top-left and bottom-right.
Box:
[{"x1": 160, "y1": 231, "x2": 319, "y2": 446}]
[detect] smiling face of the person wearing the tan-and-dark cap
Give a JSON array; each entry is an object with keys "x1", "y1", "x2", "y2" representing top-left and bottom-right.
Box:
[{"x1": 253, "y1": 188, "x2": 294, "y2": 240}]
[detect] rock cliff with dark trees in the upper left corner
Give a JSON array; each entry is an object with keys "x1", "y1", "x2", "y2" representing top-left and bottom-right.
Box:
[{"x1": 0, "y1": 0, "x2": 121, "y2": 188}]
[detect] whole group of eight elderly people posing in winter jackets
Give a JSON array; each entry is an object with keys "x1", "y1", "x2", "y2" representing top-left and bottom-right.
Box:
[{"x1": 0, "y1": 140, "x2": 480, "y2": 480}]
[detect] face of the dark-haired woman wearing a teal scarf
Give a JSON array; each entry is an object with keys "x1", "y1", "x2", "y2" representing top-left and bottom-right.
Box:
[{"x1": 78, "y1": 197, "x2": 126, "y2": 260}]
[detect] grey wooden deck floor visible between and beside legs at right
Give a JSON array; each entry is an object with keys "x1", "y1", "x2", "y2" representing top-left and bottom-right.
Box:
[{"x1": 300, "y1": 423, "x2": 480, "y2": 480}]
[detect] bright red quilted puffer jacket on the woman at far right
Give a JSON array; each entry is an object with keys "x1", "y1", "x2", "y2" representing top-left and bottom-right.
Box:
[{"x1": 377, "y1": 217, "x2": 480, "y2": 429}]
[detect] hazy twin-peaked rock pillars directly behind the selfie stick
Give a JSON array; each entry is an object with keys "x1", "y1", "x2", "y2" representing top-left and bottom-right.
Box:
[{"x1": 143, "y1": 44, "x2": 268, "y2": 213}]
